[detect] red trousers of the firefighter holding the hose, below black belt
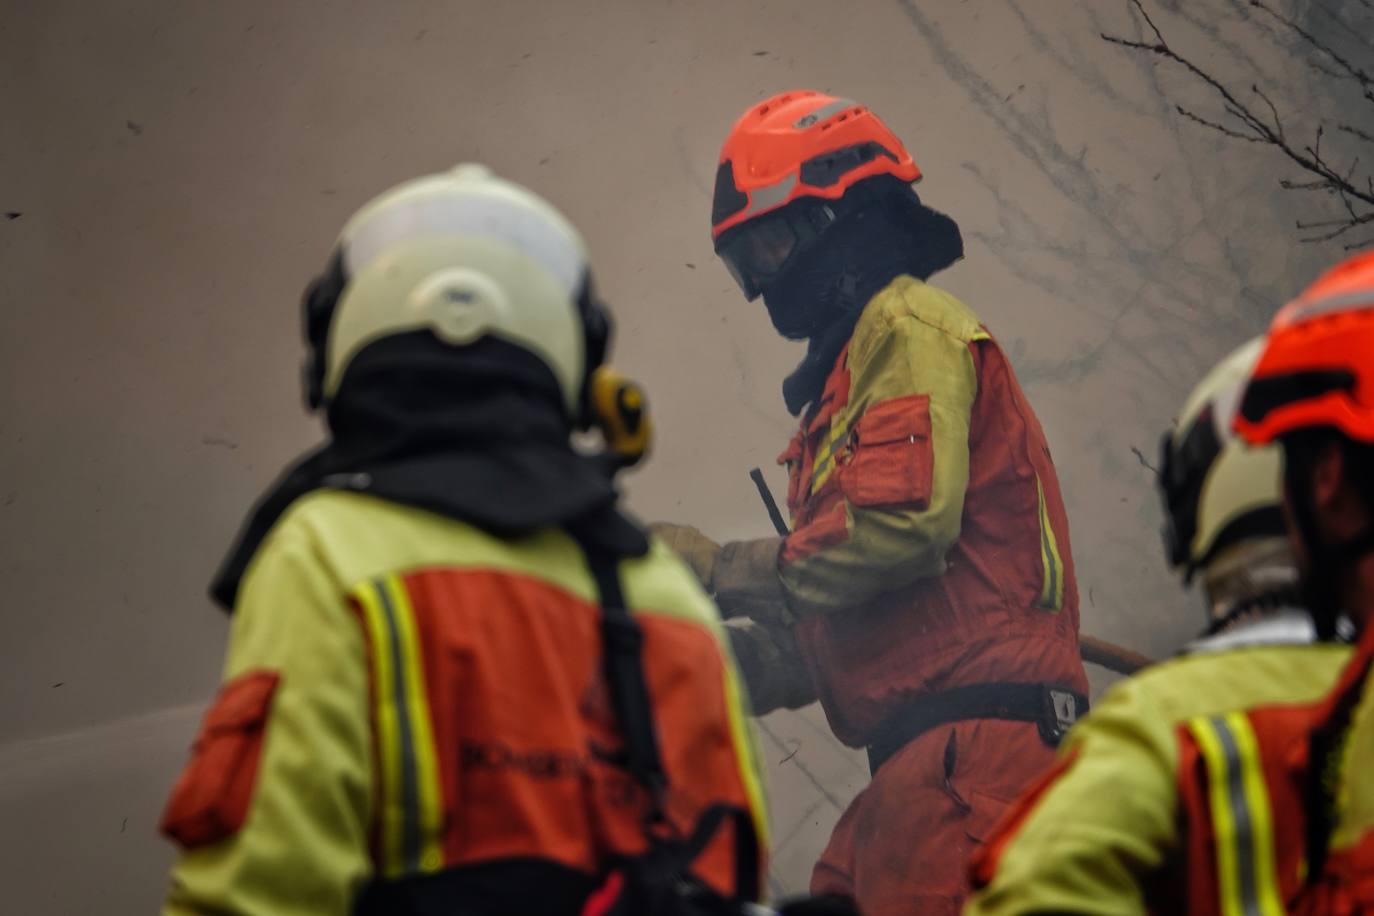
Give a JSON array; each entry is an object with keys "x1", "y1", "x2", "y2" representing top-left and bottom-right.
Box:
[{"x1": 811, "y1": 720, "x2": 1054, "y2": 916}]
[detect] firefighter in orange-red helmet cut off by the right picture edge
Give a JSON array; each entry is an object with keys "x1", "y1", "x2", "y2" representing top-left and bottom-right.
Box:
[{"x1": 1235, "y1": 253, "x2": 1374, "y2": 913}]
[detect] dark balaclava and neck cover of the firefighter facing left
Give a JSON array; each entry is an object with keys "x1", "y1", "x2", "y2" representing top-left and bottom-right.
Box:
[{"x1": 763, "y1": 176, "x2": 963, "y2": 415}]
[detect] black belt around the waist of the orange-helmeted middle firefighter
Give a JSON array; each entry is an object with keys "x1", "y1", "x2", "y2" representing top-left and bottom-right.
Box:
[{"x1": 868, "y1": 684, "x2": 1088, "y2": 773}]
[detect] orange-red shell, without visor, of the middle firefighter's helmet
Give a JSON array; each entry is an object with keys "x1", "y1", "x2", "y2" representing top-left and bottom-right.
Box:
[{"x1": 710, "y1": 89, "x2": 921, "y2": 239}]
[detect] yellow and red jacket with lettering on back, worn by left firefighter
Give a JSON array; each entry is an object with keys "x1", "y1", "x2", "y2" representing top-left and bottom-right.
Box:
[{"x1": 162, "y1": 490, "x2": 768, "y2": 916}]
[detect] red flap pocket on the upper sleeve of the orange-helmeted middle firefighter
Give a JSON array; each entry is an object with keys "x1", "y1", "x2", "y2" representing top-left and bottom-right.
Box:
[{"x1": 840, "y1": 394, "x2": 934, "y2": 509}]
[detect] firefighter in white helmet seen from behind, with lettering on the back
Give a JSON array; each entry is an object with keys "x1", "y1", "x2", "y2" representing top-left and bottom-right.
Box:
[{"x1": 162, "y1": 166, "x2": 767, "y2": 916}]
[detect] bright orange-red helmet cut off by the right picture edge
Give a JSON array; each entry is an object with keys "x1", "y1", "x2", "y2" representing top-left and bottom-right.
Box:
[{"x1": 1235, "y1": 253, "x2": 1374, "y2": 445}]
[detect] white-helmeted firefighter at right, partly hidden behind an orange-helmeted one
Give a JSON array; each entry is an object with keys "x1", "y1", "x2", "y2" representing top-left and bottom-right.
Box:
[{"x1": 967, "y1": 338, "x2": 1349, "y2": 916}]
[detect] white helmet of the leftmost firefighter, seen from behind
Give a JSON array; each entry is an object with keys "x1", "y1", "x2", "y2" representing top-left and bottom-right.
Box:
[{"x1": 305, "y1": 165, "x2": 610, "y2": 423}]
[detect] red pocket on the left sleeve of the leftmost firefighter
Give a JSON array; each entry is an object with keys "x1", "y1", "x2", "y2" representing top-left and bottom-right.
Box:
[{"x1": 161, "y1": 672, "x2": 282, "y2": 849}]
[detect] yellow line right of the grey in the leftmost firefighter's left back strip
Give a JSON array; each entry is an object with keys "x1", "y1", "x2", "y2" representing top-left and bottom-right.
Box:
[{"x1": 385, "y1": 575, "x2": 444, "y2": 872}]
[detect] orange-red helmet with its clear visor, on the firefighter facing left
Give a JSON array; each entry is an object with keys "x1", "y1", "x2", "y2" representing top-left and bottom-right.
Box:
[{"x1": 710, "y1": 89, "x2": 921, "y2": 299}]
